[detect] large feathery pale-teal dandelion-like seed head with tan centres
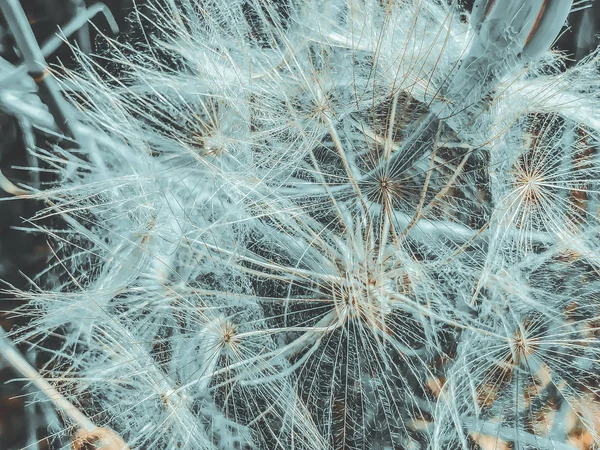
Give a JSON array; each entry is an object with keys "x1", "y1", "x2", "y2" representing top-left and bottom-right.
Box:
[{"x1": 10, "y1": 0, "x2": 600, "y2": 450}]
